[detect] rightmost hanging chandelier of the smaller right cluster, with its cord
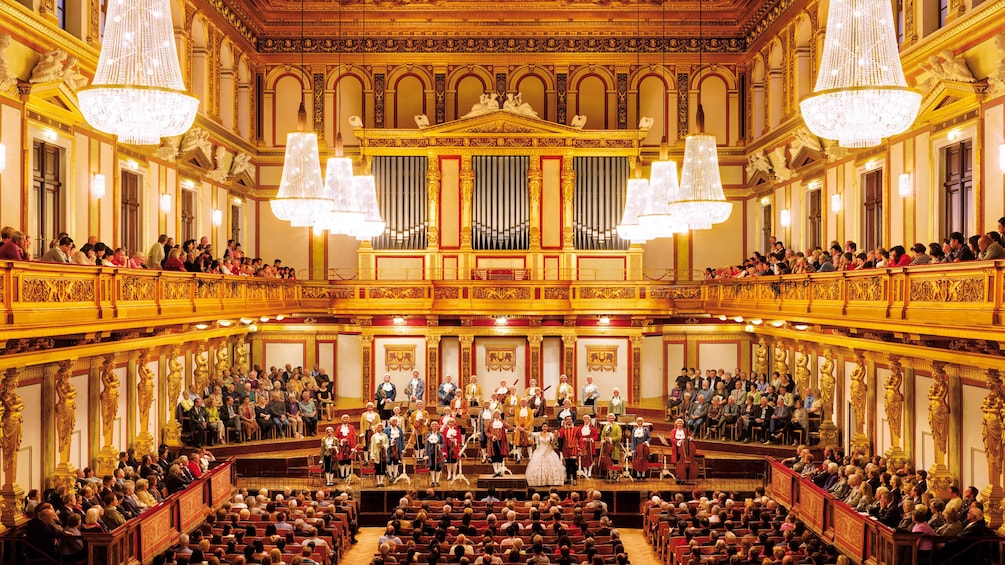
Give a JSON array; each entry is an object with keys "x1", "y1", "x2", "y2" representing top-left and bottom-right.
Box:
[{"x1": 669, "y1": 0, "x2": 733, "y2": 229}]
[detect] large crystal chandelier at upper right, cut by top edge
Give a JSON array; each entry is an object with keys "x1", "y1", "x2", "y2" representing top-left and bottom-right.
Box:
[{"x1": 799, "y1": 0, "x2": 922, "y2": 148}]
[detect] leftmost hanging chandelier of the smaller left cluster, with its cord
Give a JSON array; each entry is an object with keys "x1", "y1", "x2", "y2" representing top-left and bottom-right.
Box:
[{"x1": 269, "y1": 0, "x2": 327, "y2": 227}]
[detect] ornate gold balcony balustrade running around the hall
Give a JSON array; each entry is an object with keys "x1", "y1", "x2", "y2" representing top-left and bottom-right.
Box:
[{"x1": 0, "y1": 261, "x2": 1005, "y2": 339}]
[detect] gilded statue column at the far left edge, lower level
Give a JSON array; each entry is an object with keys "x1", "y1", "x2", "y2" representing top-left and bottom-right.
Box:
[{"x1": 0, "y1": 368, "x2": 27, "y2": 528}]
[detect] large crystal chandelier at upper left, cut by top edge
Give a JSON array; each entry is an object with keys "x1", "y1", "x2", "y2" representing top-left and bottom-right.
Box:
[{"x1": 76, "y1": 0, "x2": 199, "y2": 145}]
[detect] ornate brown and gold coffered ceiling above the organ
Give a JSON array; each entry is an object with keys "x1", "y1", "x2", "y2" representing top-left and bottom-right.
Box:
[{"x1": 203, "y1": 0, "x2": 795, "y2": 53}]
